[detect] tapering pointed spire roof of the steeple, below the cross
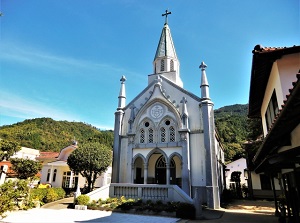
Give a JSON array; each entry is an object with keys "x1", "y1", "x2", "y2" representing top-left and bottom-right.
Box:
[{"x1": 154, "y1": 23, "x2": 177, "y2": 60}]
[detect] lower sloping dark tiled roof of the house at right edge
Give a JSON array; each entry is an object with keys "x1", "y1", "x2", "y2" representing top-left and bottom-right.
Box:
[{"x1": 253, "y1": 71, "x2": 300, "y2": 169}]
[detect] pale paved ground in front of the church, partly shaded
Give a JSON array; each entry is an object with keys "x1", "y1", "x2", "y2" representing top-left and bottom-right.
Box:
[{"x1": 0, "y1": 198, "x2": 278, "y2": 223}]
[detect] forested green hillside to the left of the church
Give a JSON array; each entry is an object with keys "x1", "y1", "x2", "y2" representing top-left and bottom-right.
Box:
[{"x1": 0, "y1": 118, "x2": 113, "y2": 152}]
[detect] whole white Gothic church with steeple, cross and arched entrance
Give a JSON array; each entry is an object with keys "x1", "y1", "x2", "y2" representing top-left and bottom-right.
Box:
[{"x1": 112, "y1": 10, "x2": 224, "y2": 209}]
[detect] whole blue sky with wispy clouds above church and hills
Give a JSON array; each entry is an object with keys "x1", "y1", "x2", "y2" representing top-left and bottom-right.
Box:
[{"x1": 0, "y1": 0, "x2": 300, "y2": 129}]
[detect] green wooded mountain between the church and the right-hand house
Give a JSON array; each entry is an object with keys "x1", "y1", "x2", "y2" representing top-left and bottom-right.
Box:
[{"x1": 214, "y1": 104, "x2": 251, "y2": 162}]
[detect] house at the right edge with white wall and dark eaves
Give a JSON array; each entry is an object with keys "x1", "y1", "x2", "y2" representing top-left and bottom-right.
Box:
[{"x1": 248, "y1": 45, "x2": 300, "y2": 222}]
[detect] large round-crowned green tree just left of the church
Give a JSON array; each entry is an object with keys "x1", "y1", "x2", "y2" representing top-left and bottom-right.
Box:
[{"x1": 67, "y1": 142, "x2": 112, "y2": 192}]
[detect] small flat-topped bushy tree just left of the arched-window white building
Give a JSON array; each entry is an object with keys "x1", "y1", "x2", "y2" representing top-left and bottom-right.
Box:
[{"x1": 10, "y1": 158, "x2": 42, "y2": 179}]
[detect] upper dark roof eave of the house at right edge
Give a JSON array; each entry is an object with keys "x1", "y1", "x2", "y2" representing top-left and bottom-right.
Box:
[{"x1": 248, "y1": 45, "x2": 300, "y2": 118}]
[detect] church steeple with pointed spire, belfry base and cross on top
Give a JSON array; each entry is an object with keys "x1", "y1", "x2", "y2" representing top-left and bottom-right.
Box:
[{"x1": 149, "y1": 10, "x2": 183, "y2": 87}]
